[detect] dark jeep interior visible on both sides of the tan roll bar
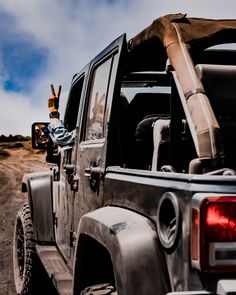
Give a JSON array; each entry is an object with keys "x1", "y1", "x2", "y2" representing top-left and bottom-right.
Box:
[{"x1": 110, "y1": 46, "x2": 236, "y2": 173}]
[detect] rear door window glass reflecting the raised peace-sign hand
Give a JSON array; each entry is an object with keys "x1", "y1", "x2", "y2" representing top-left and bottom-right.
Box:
[{"x1": 85, "y1": 58, "x2": 112, "y2": 140}]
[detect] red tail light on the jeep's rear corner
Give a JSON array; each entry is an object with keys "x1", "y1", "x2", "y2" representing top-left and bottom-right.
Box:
[{"x1": 191, "y1": 194, "x2": 236, "y2": 272}]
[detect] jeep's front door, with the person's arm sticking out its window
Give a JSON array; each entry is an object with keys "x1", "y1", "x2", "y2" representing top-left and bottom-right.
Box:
[{"x1": 53, "y1": 65, "x2": 89, "y2": 259}]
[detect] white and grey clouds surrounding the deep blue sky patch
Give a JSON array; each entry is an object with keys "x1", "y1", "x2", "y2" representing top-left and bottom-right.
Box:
[{"x1": 0, "y1": 0, "x2": 236, "y2": 134}]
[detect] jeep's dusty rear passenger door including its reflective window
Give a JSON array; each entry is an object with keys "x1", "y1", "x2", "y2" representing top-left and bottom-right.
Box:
[{"x1": 74, "y1": 35, "x2": 127, "y2": 235}]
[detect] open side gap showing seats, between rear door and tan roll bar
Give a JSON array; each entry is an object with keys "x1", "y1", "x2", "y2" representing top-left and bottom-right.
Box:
[{"x1": 120, "y1": 72, "x2": 195, "y2": 172}]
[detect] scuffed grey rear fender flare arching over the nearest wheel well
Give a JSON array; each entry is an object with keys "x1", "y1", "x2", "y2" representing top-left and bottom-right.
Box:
[{"x1": 75, "y1": 206, "x2": 170, "y2": 295}]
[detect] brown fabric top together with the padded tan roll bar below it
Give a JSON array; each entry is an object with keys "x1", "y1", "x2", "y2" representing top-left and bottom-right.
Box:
[{"x1": 129, "y1": 13, "x2": 236, "y2": 159}]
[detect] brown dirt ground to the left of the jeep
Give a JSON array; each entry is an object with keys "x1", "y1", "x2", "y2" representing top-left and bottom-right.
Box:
[{"x1": 0, "y1": 142, "x2": 50, "y2": 295}]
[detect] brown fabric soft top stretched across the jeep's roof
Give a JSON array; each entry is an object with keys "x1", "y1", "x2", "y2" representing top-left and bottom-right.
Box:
[{"x1": 130, "y1": 13, "x2": 236, "y2": 48}]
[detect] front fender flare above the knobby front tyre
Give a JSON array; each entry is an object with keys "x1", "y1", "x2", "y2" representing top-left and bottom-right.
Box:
[{"x1": 22, "y1": 171, "x2": 55, "y2": 243}]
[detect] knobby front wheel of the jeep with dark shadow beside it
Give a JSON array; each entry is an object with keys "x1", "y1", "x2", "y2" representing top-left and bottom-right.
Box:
[{"x1": 13, "y1": 204, "x2": 56, "y2": 295}]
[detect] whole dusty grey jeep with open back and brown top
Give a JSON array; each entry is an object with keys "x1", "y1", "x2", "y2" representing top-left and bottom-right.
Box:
[{"x1": 13, "y1": 14, "x2": 236, "y2": 295}]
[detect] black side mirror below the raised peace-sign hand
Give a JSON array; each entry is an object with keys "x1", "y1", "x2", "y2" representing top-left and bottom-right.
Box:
[{"x1": 32, "y1": 122, "x2": 49, "y2": 150}]
